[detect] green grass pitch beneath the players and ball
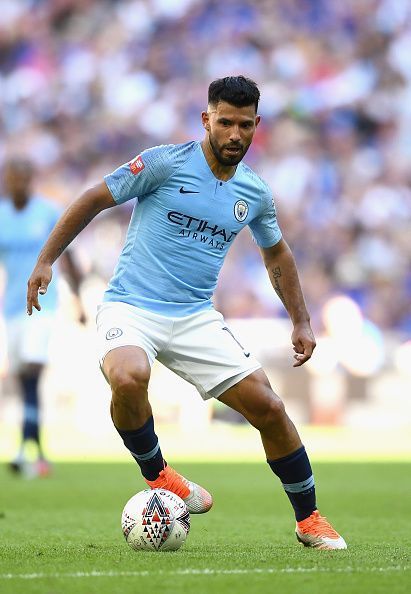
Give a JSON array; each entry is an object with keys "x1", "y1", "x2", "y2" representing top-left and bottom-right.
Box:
[{"x1": 0, "y1": 462, "x2": 411, "y2": 594}]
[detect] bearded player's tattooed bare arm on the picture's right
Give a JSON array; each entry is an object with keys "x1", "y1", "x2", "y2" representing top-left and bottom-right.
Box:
[{"x1": 260, "y1": 238, "x2": 315, "y2": 367}]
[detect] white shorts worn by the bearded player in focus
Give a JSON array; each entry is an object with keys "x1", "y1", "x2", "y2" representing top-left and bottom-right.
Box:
[{"x1": 96, "y1": 302, "x2": 261, "y2": 400}]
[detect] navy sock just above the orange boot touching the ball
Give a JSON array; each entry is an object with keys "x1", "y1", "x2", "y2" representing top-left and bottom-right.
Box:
[{"x1": 116, "y1": 416, "x2": 166, "y2": 481}]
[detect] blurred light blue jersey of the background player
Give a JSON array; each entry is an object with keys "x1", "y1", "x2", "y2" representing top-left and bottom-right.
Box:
[{"x1": 0, "y1": 196, "x2": 59, "y2": 319}]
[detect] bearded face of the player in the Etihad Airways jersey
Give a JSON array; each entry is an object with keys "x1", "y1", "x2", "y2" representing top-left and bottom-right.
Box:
[{"x1": 202, "y1": 101, "x2": 260, "y2": 166}]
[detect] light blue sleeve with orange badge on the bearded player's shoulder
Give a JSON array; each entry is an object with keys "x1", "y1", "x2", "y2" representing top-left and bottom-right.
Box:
[{"x1": 104, "y1": 143, "x2": 194, "y2": 204}]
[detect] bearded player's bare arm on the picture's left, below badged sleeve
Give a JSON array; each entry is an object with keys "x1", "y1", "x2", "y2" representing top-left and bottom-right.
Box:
[{"x1": 27, "y1": 182, "x2": 116, "y2": 316}]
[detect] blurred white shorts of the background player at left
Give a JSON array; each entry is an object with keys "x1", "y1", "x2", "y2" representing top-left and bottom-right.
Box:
[{"x1": 6, "y1": 313, "x2": 54, "y2": 373}]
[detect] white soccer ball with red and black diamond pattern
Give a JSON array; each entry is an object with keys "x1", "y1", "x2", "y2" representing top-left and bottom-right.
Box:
[{"x1": 121, "y1": 489, "x2": 190, "y2": 551}]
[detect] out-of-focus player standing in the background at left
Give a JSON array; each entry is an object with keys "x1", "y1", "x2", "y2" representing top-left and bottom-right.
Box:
[{"x1": 0, "y1": 157, "x2": 83, "y2": 476}]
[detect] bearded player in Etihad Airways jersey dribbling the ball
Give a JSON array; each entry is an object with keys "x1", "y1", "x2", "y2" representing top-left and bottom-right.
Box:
[{"x1": 27, "y1": 76, "x2": 346, "y2": 549}]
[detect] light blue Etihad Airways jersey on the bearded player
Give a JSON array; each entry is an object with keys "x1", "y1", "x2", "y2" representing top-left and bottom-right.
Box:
[{"x1": 104, "y1": 142, "x2": 281, "y2": 317}]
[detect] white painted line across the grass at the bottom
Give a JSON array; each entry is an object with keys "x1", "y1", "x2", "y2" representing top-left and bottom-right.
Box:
[{"x1": 0, "y1": 565, "x2": 410, "y2": 580}]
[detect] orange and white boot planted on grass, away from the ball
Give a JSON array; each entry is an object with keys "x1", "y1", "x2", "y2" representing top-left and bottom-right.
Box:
[{"x1": 295, "y1": 510, "x2": 347, "y2": 550}]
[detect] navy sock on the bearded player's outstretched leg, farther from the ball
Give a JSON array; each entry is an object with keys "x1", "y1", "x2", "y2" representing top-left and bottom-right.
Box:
[{"x1": 267, "y1": 446, "x2": 317, "y2": 522}]
